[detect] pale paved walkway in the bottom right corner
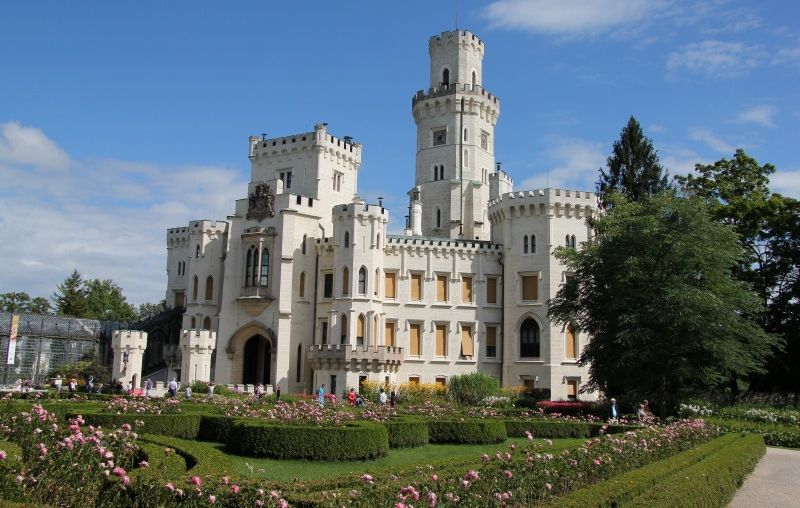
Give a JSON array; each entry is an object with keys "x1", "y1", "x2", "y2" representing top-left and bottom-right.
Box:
[{"x1": 728, "y1": 447, "x2": 800, "y2": 508}]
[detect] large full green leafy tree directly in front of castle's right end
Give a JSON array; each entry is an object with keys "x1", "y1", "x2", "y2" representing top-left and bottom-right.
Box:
[{"x1": 550, "y1": 191, "x2": 780, "y2": 416}]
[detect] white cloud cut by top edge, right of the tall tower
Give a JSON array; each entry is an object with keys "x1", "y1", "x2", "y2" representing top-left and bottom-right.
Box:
[{"x1": 485, "y1": 0, "x2": 668, "y2": 36}]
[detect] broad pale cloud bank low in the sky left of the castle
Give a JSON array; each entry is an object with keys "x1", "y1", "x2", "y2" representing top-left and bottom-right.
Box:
[{"x1": 0, "y1": 124, "x2": 249, "y2": 303}]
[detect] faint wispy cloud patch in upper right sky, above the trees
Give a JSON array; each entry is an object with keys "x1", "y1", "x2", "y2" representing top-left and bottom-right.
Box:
[{"x1": 667, "y1": 41, "x2": 766, "y2": 78}]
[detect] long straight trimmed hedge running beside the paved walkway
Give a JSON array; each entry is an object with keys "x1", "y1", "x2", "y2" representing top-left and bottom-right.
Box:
[{"x1": 548, "y1": 434, "x2": 766, "y2": 508}]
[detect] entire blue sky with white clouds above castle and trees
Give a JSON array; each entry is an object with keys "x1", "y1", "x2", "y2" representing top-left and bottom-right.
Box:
[{"x1": 0, "y1": 0, "x2": 800, "y2": 303}]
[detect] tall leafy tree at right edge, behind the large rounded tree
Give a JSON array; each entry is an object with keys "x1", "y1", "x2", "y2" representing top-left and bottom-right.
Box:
[{"x1": 677, "y1": 149, "x2": 800, "y2": 396}]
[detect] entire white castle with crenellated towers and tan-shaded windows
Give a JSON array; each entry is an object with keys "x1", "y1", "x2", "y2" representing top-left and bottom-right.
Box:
[{"x1": 166, "y1": 30, "x2": 596, "y2": 399}]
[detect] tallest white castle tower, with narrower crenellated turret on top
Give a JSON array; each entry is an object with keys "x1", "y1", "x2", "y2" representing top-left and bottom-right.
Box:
[{"x1": 408, "y1": 30, "x2": 500, "y2": 240}]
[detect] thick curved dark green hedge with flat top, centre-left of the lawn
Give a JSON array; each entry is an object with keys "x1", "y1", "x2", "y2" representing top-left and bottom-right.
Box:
[{"x1": 227, "y1": 420, "x2": 390, "y2": 460}]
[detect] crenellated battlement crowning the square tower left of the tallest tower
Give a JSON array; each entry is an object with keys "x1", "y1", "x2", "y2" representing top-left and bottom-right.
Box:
[{"x1": 249, "y1": 123, "x2": 361, "y2": 161}]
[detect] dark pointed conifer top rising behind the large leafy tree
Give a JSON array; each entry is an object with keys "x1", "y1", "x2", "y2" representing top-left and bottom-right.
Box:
[{"x1": 597, "y1": 116, "x2": 669, "y2": 207}]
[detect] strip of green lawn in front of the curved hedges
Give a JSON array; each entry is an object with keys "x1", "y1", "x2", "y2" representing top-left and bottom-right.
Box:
[{"x1": 216, "y1": 438, "x2": 586, "y2": 481}]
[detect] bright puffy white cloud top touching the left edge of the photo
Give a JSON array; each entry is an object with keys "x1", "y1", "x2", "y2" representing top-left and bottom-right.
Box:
[{"x1": 0, "y1": 122, "x2": 69, "y2": 169}]
